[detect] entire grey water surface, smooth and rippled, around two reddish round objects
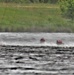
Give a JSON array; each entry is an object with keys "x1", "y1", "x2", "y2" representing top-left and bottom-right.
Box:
[{"x1": 0, "y1": 33, "x2": 74, "y2": 75}]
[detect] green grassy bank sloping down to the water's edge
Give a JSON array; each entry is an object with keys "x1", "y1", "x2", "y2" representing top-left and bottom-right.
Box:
[{"x1": 0, "y1": 3, "x2": 74, "y2": 32}]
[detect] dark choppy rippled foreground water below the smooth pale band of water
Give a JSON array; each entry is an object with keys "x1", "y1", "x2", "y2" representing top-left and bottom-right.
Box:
[{"x1": 0, "y1": 47, "x2": 74, "y2": 75}]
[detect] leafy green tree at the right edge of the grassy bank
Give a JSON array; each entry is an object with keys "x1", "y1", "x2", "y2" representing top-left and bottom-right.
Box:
[{"x1": 60, "y1": 0, "x2": 74, "y2": 20}]
